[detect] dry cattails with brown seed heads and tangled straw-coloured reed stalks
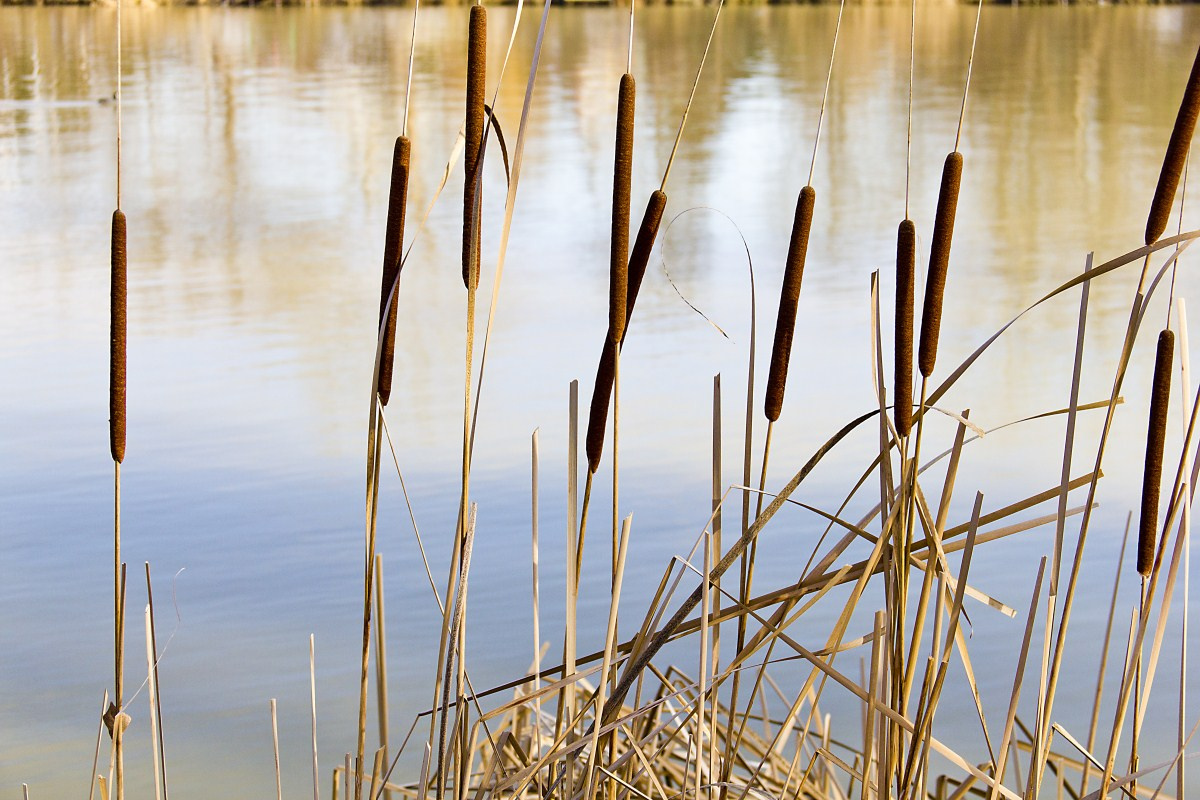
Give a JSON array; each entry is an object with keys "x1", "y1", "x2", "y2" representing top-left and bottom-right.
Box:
[{"x1": 77, "y1": 0, "x2": 1200, "y2": 800}]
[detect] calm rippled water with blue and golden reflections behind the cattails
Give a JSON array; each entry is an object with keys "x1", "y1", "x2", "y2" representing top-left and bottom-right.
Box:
[{"x1": 0, "y1": 6, "x2": 1200, "y2": 798}]
